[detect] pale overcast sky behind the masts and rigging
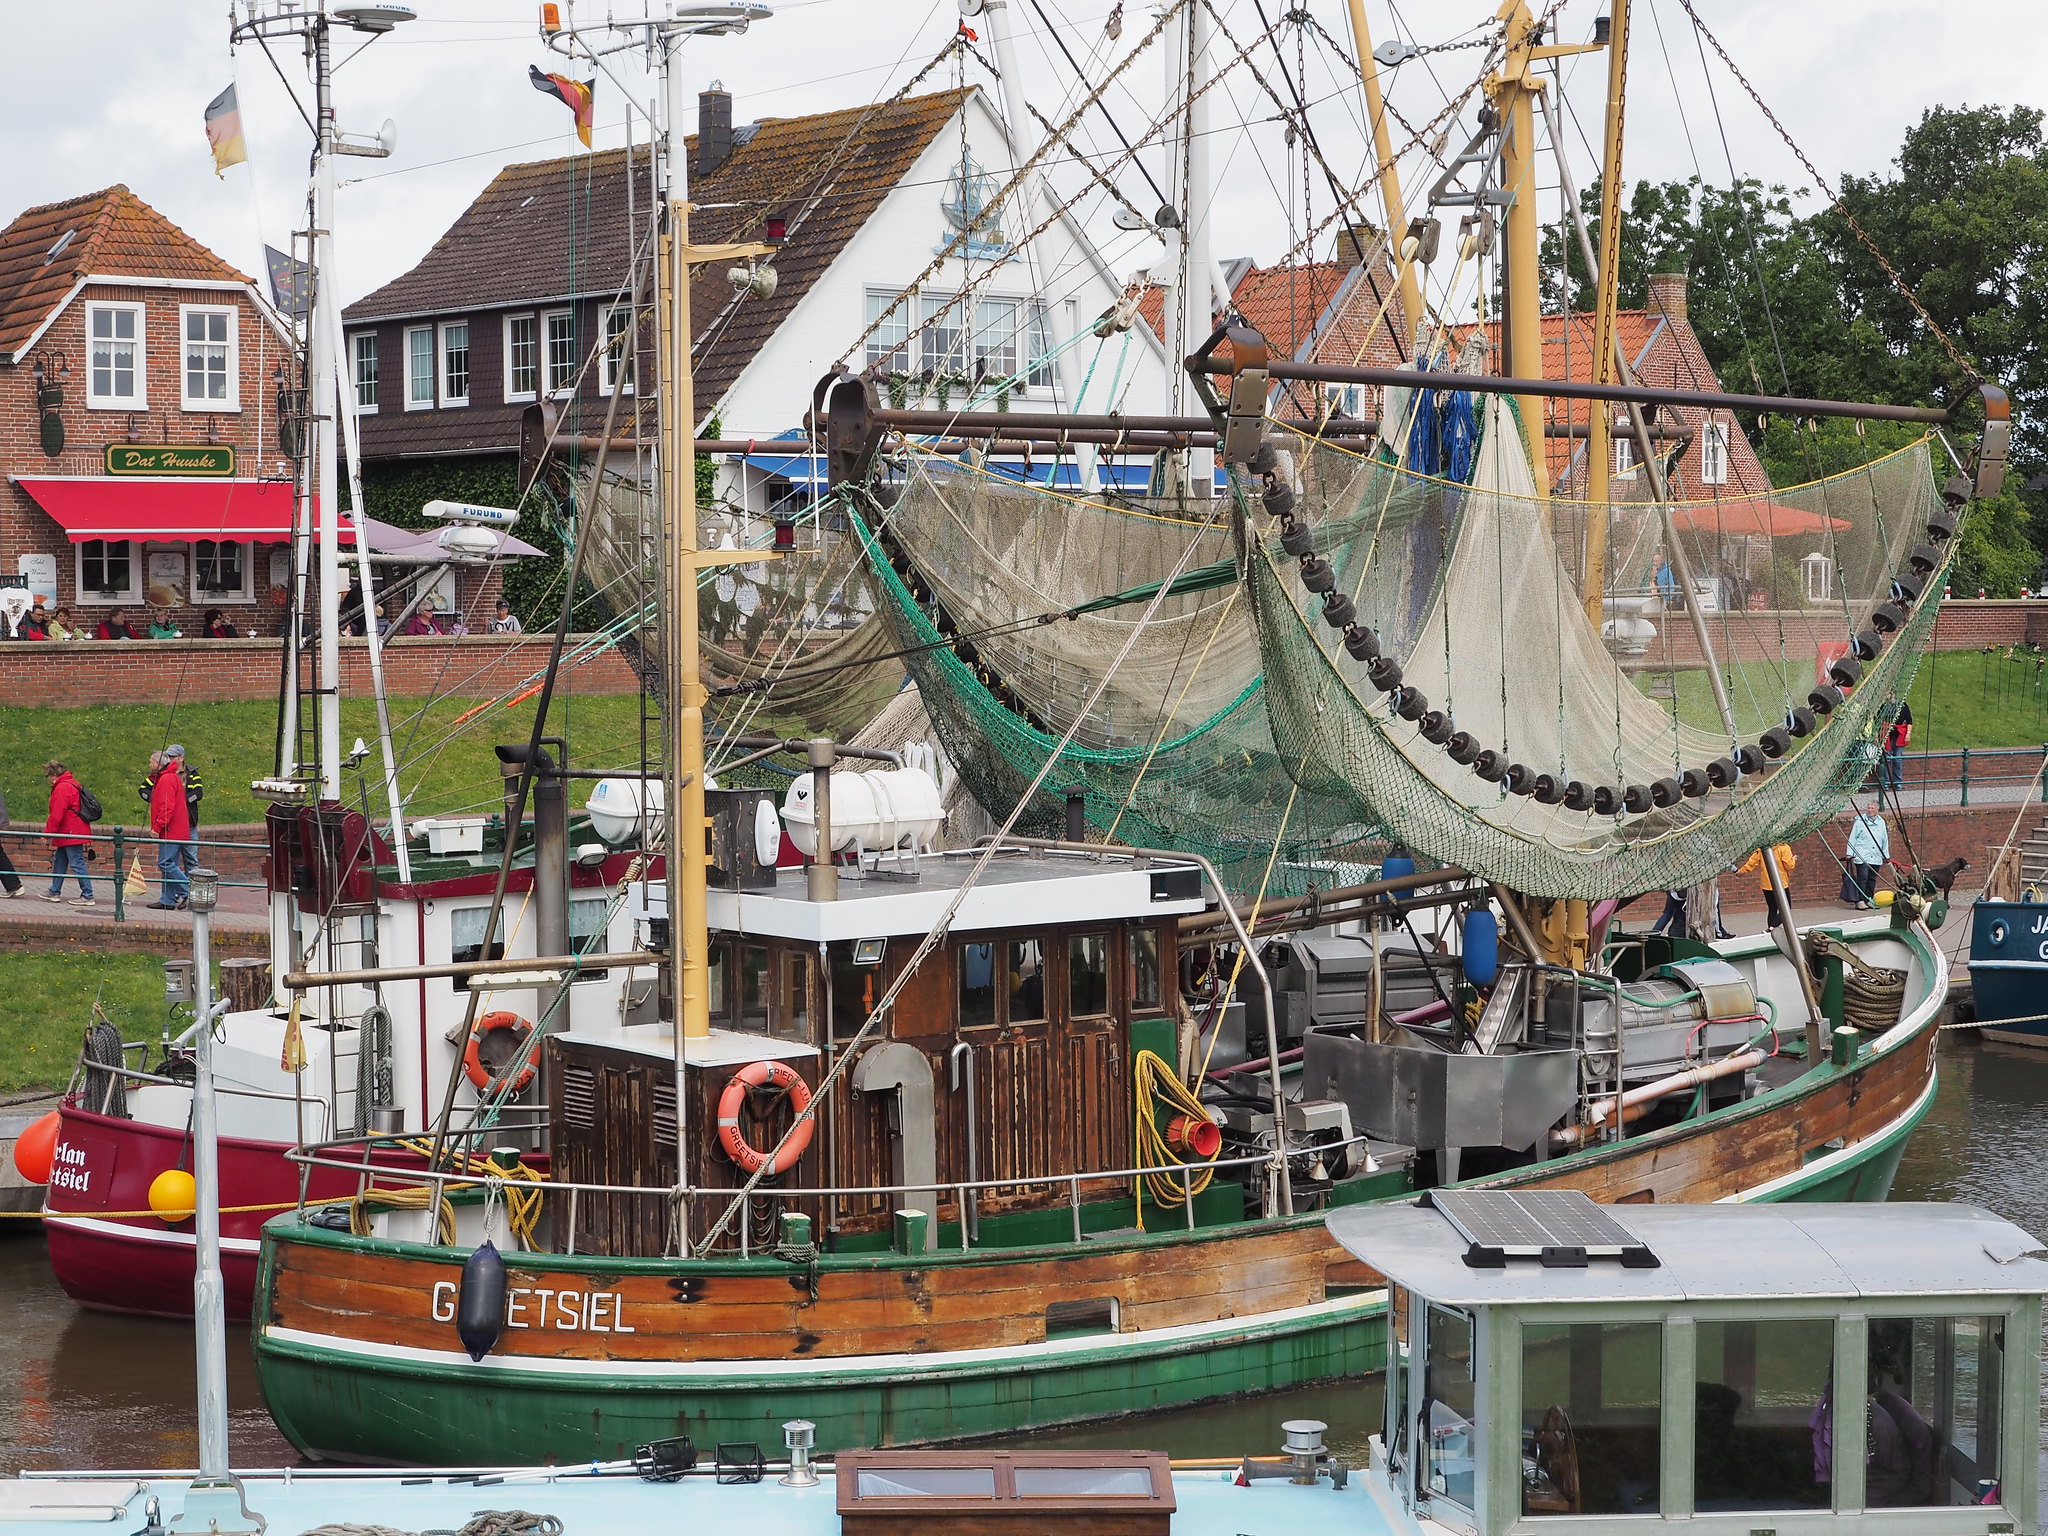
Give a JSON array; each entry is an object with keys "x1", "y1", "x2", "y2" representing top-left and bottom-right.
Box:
[{"x1": 0, "y1": 0, "x2": 2048, "y2": 315}]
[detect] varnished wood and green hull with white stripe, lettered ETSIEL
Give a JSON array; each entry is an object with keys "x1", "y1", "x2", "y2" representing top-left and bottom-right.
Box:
[{"x1": 254, "y1": 950, "x2": 1939, "y2": 1462}]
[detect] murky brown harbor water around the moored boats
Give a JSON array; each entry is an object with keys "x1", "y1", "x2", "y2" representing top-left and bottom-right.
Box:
[{"x1": 0, "y1": 1032, "x2": 2048, "y2": 1481}]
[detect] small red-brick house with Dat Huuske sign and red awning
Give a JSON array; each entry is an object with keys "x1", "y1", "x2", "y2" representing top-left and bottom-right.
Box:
[{"x1": 0, "y1": 186, "x2": 295, "y2": 635}]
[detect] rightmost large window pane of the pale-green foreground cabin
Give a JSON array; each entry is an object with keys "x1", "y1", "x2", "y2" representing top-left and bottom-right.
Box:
[{"x1": 1864, "y1": 1317, "x2": 1998, "y2": 1509}]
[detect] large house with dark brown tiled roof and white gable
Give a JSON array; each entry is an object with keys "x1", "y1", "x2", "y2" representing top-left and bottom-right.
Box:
[{"x1": 344, "y1": 88, "x2": 1165, "y2": 512}]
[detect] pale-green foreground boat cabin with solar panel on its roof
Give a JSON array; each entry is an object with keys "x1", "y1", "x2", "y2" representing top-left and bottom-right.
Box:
[{"x1": 1329, "y1": 1190, "x2": 2048, "y2": 1536}]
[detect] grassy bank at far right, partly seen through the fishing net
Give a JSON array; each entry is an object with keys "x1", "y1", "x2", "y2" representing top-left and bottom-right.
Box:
[{"x1": 1636, "y1": 651, "x2": 2048, "y2": 752}]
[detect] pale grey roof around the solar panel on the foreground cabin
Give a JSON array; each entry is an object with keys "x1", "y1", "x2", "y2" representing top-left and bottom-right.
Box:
[{"x1": 1329, "y1": 1190, "x2": 2048, "y2": 1307}]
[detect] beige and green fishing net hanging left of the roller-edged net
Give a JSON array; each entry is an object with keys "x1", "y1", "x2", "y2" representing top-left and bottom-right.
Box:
[{"x1": 868, "y1": 459, "x2": 1378, "y2": 891}]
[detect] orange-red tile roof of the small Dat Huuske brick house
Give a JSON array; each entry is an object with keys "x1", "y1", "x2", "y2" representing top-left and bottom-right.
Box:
[{"x1": 0, "y1": 186, "x2": 250, "y2": 360}]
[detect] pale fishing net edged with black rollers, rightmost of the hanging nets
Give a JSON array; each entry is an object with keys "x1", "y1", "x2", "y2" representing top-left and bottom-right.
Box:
[{"x1": 1239, "y1": 399, "x2": 1942, "y2": 897}]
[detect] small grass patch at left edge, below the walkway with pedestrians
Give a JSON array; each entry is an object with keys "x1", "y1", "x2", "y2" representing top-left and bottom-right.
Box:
[{"x1": 0, "y1": 954, "x2": 184, "y2": 1094}]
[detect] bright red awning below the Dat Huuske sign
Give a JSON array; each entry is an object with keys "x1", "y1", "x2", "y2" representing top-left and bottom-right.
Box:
[{"x1": 14, "y1": 475, "x2": 356, "y2": 545}]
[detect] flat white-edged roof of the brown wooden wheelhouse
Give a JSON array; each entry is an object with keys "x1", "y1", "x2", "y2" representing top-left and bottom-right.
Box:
[{"x1": 675, "y1": 848, "x2": 1206, "y2": 944}]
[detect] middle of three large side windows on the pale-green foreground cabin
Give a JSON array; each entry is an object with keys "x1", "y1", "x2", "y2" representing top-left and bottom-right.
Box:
[{"x1": 1692, "y1": 1317, "x2": 1837, "y2": 1513}]
